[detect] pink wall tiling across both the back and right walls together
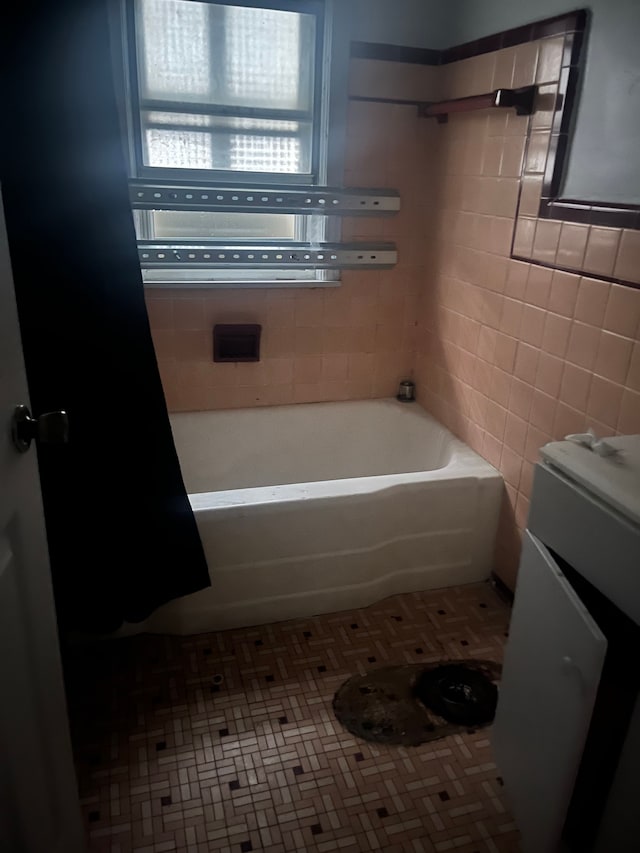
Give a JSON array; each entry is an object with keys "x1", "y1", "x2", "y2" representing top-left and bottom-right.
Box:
[{"x1": 147, "y1": 37, "x2": 640, "y2": 586}]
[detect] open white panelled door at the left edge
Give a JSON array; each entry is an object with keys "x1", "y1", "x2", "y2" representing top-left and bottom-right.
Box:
[{"x1": 0, "y1": 185, "x2": 84, "y2": 853}]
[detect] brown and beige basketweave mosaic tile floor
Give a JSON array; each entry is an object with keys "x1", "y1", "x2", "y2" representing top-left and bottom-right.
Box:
[{"x1": 65, "y1": 583, "x2": 520, "y2": 853}]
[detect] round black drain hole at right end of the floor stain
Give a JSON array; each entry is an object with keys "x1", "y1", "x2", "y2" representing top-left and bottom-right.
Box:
[{"x1": 415, "y1": 663, "x2": 498, "y2": 726}]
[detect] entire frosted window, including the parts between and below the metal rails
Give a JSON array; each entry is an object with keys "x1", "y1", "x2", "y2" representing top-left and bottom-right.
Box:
[{"x1": 119, "y1": 0, "x2": 346, "y2": 283}]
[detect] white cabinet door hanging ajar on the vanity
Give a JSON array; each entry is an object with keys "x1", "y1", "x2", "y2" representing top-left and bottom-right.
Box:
[{"x1": 491, "y1": 531, "x2": 607, "y2": 853}]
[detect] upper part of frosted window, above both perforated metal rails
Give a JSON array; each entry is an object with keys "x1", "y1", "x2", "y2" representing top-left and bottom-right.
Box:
[{"x1": 134, "y1": 0, "x2": 321, "y2": 180}]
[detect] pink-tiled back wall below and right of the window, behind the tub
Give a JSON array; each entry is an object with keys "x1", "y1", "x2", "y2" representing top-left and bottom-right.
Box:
[{"x1": 142, "y1": 59, "x2": 435, "y2": 411}]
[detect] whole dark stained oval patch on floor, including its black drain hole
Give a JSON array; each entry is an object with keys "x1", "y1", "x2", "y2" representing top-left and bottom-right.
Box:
[{"x1": 333, "y1": 660, "x2": 501, "y2": 746}]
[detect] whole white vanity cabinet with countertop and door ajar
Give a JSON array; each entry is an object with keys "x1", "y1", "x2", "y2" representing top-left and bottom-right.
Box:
[{"x1": 491, "y1": 436, "x2": 640, "y2": 853}]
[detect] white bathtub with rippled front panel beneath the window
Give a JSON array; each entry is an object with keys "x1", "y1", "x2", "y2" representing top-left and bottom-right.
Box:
[{"x1": 139, "y1": 399, "x2": 502, "y2": 634}]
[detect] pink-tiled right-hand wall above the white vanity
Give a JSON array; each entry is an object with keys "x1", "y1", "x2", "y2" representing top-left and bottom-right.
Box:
[{"x1": 416, "y1": 37, "x2": 640, "y2": 586}]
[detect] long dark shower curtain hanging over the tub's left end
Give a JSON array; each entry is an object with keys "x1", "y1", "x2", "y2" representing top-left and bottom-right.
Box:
[{"x1": 0, "y1": 0, "x2": 209, "y2": 634}]
